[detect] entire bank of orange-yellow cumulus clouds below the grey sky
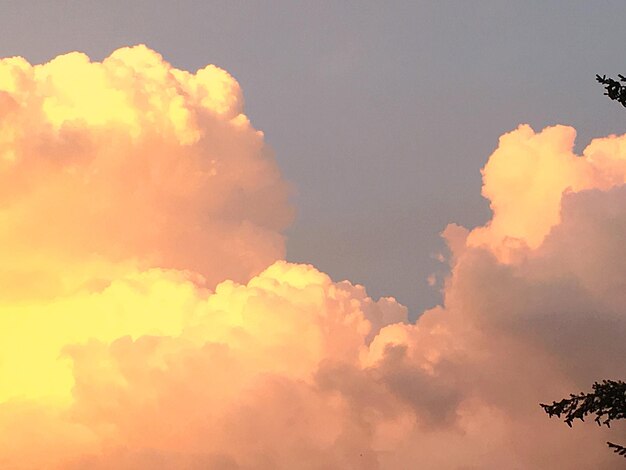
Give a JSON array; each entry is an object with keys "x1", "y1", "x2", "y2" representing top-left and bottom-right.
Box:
[{"x1": 0, "y1": 46, "x2": 626, "y2": 470}]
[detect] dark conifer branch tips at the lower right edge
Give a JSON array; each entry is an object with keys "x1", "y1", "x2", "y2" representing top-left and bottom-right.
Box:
[{"x1": 540, "y1": 380, "x2": 626, "y2": 457}]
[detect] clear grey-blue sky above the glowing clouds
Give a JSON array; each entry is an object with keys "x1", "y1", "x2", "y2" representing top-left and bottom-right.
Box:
[{"x1": 0, "y1": 1, "x2": 626, "y2": 316}]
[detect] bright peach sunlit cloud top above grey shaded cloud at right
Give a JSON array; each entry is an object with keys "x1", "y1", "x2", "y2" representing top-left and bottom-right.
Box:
[{"x1": 469, "y1": 125, "x2": 626, "y2": 260}]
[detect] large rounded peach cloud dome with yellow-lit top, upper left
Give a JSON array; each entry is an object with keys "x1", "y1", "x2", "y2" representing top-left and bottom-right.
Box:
[{"x1": 0, "y1": 46, "x2": 291, "y2": 295}]
